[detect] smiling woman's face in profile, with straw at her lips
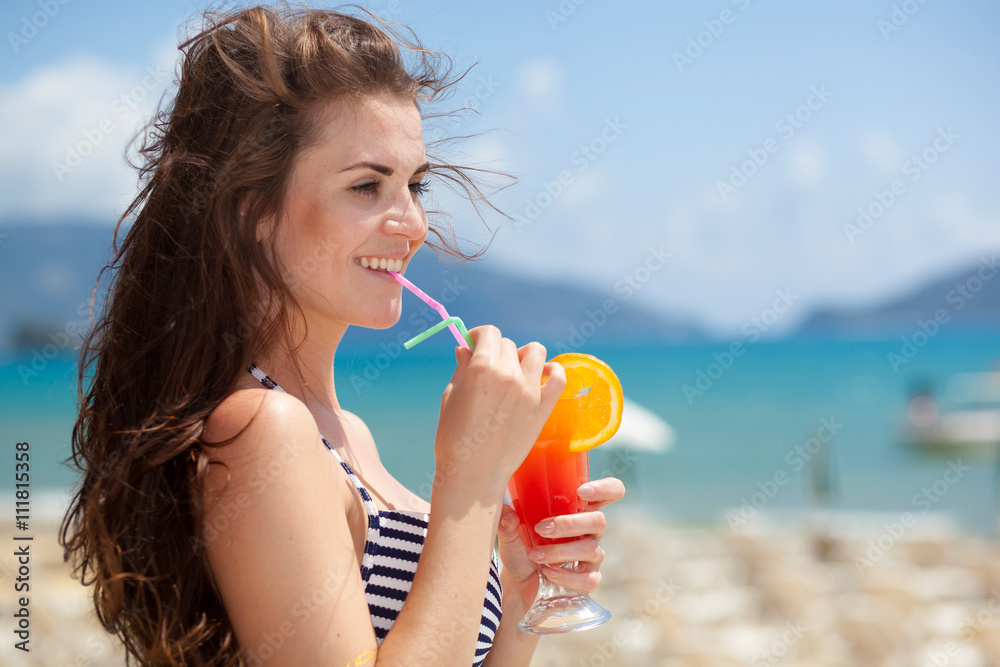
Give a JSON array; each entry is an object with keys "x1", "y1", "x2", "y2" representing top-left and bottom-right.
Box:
[{"x1": 274, "y1": 97, "x2": 428, "y2": 330}]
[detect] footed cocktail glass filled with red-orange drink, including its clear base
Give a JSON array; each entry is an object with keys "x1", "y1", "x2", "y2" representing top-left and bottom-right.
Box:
[{"x1": 507, "y1": 398, "x2": 611, "y2": 635}]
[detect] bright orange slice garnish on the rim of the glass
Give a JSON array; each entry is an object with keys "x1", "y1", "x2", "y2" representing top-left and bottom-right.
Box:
[{"x1": 552, "y1": 352, "x2": 624, "y2": 452}]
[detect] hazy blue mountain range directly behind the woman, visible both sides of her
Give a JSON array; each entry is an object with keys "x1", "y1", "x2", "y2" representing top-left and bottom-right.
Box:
[{"x1": 0, "y1": 224, "x2": 703, "y2": 352}]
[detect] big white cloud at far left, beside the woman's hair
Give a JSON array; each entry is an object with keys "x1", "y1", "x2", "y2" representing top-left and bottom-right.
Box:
[{"x1": 0, "y1": 49, "x2": 176, "y2": 223}]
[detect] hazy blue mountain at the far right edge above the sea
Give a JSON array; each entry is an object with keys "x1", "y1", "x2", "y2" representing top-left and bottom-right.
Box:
[{"x1": 796, "y1": 254, "x2": 1000, "y2": 337}]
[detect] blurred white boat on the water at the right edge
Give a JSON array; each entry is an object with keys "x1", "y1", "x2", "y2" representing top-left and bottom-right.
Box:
[{"x1": 903, "y1": 371, "x2": 1000, "y2": 452}]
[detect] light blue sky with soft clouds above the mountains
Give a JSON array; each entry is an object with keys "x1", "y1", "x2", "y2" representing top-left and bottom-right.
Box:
[{"x1": 0, "y1": 0, "x2": 1000, "y2": 336}]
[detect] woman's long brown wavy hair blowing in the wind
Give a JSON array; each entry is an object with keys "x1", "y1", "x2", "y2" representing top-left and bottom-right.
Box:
[{"x1": 60, "y1": 7, "x2": 498, "y2": 665}]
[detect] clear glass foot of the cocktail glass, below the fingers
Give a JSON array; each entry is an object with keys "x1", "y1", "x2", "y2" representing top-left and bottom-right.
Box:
[{"x1": 517, "y1": 563, "x2": 611, "y2": 635}]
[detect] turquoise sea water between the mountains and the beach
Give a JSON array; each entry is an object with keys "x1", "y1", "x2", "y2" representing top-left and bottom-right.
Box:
[{"x1": 0, "y1": 332, "x2": 1000, "y2": 534}]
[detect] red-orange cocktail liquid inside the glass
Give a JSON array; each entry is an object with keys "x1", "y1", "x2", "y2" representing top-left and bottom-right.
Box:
[{"x1": 507, "y1": 398, "x2": 589, "y2": 549}]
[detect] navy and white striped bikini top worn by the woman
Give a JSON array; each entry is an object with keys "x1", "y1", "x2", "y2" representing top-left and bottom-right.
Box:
[{"x1": 247, "y1": 364, "x2": 502, "y2": 667}]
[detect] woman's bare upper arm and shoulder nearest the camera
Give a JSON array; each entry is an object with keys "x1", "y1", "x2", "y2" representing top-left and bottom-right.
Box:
[{"x1": 203, "y1": 389, "x2": 376, "y2": 665}]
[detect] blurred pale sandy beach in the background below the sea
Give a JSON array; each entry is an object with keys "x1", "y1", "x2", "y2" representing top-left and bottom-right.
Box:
[{"x1": 0, "y1": 508, "x2": 1000, "y2": 667}]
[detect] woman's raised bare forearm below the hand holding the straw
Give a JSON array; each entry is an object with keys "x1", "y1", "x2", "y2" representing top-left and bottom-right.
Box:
[{"x1": 377, "y1": 492, "x2": 501, "y2": 667}]
